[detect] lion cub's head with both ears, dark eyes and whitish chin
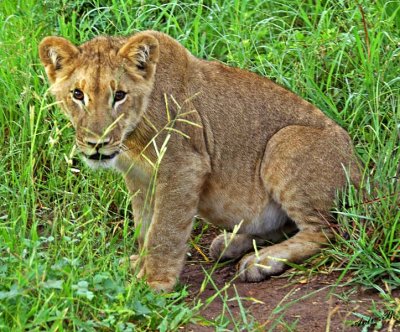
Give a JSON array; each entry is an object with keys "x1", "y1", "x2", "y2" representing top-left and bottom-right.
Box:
[{"x1": 39, "y1": 33, "x2": 159, "y2": 167}]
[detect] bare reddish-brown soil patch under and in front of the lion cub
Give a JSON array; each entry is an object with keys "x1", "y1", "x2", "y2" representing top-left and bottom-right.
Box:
[{"x1": 181, "y1": 229, "x2": 400, "y2": 332}]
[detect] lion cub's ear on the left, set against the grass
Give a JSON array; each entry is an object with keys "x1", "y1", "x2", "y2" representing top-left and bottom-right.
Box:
[{"x1": 39, "y1": 37, "x2": 79, "y2": 83}]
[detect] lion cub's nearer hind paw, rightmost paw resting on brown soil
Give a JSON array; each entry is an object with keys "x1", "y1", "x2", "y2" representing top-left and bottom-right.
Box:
[{"x1": 238, "y1": 249, "x2": 287, "y2": 282}]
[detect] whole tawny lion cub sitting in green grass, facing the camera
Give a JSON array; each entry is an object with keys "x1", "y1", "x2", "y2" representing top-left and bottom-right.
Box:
[{"x1": 40, "y1": 31, "x2": 359, "y2": 290}]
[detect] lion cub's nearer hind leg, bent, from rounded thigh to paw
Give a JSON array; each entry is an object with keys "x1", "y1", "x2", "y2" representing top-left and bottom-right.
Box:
[{"x1": 239, "y1": 126, "x2": 358, "y2": 282}]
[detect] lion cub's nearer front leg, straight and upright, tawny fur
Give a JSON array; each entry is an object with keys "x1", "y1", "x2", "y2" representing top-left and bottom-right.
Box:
[{"x1": 138, "y1": 160, "x2": 205, "y2": 291}]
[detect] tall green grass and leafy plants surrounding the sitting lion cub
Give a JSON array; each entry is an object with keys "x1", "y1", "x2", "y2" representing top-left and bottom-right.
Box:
[{"x1": 0, "y1": 0, "x2": 400, "y2": 331}]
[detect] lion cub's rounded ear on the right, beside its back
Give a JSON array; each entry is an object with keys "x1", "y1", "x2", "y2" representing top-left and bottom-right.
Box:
[{"x1": 118, "y1": 34, "x2": 160, "y2": 79}]
